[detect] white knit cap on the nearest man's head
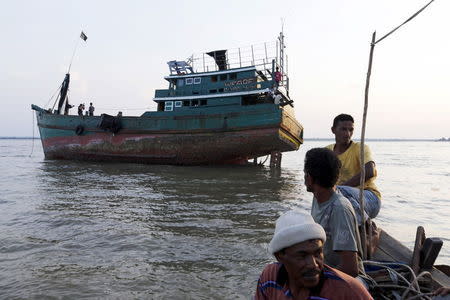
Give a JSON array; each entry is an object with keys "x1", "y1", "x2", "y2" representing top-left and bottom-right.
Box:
[{"x1": 269, "y1": 210, "x2": 327, "y2": 254}]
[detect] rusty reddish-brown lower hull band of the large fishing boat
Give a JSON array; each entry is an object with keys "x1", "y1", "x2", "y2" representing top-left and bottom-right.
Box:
[{"x1": 42, "y1": 128, "x2": 300, "y2": 165}]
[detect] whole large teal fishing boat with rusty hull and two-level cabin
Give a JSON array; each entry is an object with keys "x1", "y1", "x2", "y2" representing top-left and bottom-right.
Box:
[{"x1": 32, "y1": 33, "x2": 303, "y2": 165}]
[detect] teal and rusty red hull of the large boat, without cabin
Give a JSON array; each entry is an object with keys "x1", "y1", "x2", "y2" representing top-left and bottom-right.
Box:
[{"x1": 33, "y1": 103, "x2": 302, "y2": 165}]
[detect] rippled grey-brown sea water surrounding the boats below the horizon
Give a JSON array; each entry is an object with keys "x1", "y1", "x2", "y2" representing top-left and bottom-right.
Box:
[{"x1": 0, "y1": 140, "x2": 450, "y2": 299}]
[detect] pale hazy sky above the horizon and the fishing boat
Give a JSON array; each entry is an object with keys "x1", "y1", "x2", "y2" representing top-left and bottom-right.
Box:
[{"x1": 0, "y1": 0, "x2": 450, "y2": 139}]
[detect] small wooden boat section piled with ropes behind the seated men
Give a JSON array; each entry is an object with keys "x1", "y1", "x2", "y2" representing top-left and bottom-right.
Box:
[{"x1": 364, "y1": 226, "x2": 450, "y2": 299}]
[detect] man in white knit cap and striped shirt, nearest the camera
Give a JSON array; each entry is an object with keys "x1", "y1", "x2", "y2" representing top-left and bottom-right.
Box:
[{"x1": 255, "y1": 211, "x2": 372, "y2": 300}]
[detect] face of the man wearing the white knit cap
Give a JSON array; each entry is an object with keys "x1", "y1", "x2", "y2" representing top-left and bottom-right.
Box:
[{"x1": 276, "y1": 240, "x2": 323, "y2": 288}]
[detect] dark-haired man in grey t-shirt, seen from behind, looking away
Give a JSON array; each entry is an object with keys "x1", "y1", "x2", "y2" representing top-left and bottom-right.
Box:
[{"x1": 304, "y1": 148, "x2": 364, "y2": 277}]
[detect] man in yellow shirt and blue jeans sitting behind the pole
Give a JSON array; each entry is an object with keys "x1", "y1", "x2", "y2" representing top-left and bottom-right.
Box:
[{"x1": 326, "y1": 114, "x2": 381, "y2": 224}]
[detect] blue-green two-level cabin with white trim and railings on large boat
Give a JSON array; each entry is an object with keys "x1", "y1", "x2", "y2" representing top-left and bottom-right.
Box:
[{"x1": 153, "y1": 34, "x2": 292, "y2": 113}]
